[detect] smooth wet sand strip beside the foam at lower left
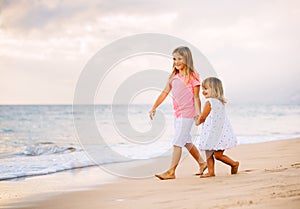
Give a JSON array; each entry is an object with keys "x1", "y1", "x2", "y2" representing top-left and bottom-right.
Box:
[{"x1": 0, "y1": 166, "x2": 115, "y2": 209}]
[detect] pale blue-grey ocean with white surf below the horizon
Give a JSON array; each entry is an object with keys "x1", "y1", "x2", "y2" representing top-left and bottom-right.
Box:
[{"x1": 0, "y1": 104, "x2": 300, "y2": 181}]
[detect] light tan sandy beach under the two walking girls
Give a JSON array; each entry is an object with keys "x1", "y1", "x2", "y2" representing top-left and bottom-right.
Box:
[{"x1": 0, "y1": 139, "x2": 300, "y2": 209}]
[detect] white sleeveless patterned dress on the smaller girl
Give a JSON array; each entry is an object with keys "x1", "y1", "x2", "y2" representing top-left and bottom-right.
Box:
[{"x1": 197, "y1": 98, "x2": 237, "y2": 150}]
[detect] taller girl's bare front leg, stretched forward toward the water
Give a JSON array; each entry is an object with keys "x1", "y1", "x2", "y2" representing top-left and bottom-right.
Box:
[{"x1": 155, "y1": 146, "x2": 182, "y2": 180}]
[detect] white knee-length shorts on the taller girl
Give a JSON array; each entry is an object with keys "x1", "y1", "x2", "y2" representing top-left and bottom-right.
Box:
[{"x1": 173, "y1": 118, "x2": 194, "y2": 147}]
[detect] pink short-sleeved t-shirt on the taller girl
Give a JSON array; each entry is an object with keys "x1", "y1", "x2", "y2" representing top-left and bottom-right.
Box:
[{"x1": 170, "y1": 74, "x2": 200, "y2": 118}]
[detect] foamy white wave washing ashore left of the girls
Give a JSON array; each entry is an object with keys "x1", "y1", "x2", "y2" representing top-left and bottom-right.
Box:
[{"x1": 0, "y1": 142, "x2": 169, "y2": 181}]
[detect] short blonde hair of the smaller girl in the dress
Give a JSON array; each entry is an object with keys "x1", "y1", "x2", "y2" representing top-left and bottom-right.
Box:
[{"x1": 202, "y1": 77, "x2": 227, "y2": 104}]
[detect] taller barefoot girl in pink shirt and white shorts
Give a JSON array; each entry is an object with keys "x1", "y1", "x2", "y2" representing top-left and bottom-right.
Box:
[{"x1": 149, "y1": 47, "x2": 207, "y2": 180}]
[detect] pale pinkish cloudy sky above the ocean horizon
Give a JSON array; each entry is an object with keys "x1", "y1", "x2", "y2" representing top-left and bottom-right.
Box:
[{"x1": 0, "y1": 0, "x2": 300, "y2": 105}]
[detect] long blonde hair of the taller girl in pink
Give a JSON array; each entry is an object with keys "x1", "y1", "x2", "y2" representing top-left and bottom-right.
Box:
[{"x1": 170, "y1": 46, "x2": 199, "y2": 83}]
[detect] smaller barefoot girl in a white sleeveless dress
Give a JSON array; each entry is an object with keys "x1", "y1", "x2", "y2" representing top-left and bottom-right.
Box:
[{"x1": 196, "y1": 77, "x2": 239, "y2": 178}]
